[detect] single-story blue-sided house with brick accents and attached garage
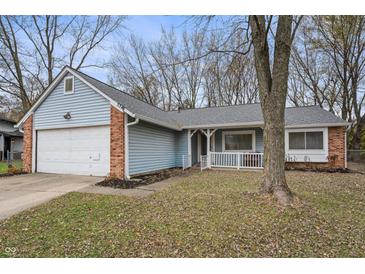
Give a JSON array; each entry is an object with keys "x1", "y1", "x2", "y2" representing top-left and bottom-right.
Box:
[{"x1": 17, "y1": 67, "x2": 348, "y2": 177}]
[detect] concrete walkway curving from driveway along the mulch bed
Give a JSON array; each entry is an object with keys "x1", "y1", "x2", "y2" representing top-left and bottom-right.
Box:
[{"x1": 79, "y1": 177, "x2": 179, "y2": 198}]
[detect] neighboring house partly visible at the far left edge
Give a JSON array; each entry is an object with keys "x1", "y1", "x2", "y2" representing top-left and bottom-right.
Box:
[{"x1": 0, "y1": 118, "x2": 23, "y2": 161}]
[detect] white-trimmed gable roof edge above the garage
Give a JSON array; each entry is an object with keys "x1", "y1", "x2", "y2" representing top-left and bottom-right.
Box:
[{"x1": 14, "y1": 66, "x2": 135, "y2": 128}]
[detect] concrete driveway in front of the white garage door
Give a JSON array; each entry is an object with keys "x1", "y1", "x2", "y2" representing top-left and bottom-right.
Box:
[{"x1": 0, "y1": 173, "x2": 102, "y2": 220}]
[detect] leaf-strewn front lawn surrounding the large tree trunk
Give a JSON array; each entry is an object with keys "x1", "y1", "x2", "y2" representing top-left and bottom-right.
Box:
[{"x1": 0, "y1": 171, "x2": 365, "y2": 257}]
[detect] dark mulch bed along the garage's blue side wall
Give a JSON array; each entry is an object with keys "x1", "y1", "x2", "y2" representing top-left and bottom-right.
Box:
[{"x1": 96, "y1": 168, "x2": 183, "y2": 189}]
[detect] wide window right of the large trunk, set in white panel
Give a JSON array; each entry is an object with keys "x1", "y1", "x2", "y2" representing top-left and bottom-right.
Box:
[{"x1": 289, "y1": 131, "x2": 323, "y2": 149}]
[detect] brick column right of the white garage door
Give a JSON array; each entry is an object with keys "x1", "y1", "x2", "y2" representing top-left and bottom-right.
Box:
[{"x1": 110, "y1": 106, "x2": 125, "y2": 178}]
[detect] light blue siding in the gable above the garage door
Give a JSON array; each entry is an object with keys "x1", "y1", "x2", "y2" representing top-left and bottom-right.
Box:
[{"x1": 34, "y1": 73, "x2": 110, "y2": 129}]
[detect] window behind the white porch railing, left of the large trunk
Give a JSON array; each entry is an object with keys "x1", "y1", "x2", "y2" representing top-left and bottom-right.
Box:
[{"x1": 223, "y1": 131, "x2": 255, "y2": 151}]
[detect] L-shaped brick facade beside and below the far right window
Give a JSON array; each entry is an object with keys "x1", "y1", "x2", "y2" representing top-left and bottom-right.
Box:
[{"x1": 286, "y1": 127, "x2": 346, "y2": 169}]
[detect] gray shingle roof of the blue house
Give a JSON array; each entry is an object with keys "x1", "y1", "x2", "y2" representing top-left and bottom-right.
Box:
[{"x1": 69, "y1": 67, "x2": 346, "y2": 129}]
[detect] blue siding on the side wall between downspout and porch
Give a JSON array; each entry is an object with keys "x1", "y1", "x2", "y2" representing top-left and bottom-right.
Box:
[{"x1": 128, "y1": 121, "x2": 177, "y2": 175}]
